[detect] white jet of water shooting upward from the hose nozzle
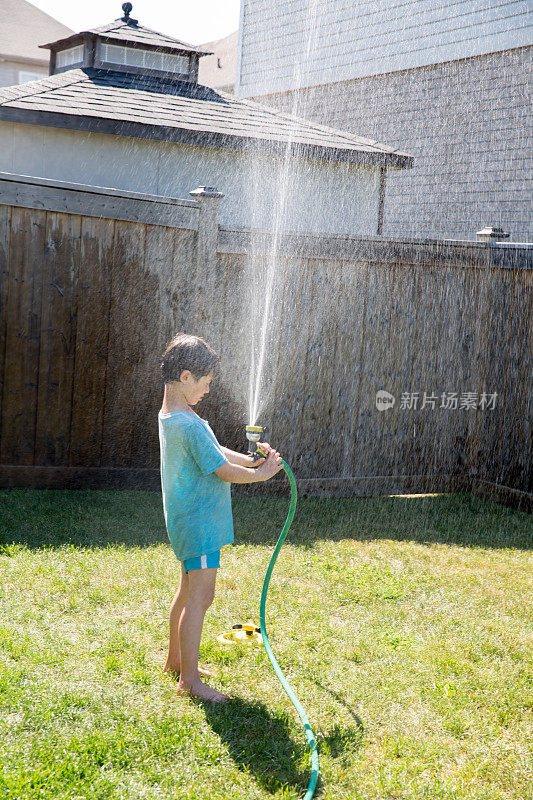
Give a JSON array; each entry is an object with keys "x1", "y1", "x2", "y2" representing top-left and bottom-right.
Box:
[{"x1": 248, "y1": 0, "x2": 318, "y2": 425}]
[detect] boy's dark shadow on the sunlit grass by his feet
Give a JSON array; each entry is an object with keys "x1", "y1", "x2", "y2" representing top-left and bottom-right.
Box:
[{"x1": 200, "y1": 698, "x2": 310, "y2": 794}]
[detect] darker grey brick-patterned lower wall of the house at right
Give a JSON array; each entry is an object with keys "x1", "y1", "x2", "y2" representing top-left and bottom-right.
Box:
[{"x1": 251, "y1": 47, "x2": 533, "y2": 241}]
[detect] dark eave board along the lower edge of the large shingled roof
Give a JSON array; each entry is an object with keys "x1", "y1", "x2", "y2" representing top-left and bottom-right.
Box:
[{"x1": 0, "y1": 106, "x2": 413, "y2": 169}]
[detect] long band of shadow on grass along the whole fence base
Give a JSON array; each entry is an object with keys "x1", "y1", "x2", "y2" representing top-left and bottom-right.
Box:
[{"x1": 0, "y1": 489, "x2": 533, "y2": 550}]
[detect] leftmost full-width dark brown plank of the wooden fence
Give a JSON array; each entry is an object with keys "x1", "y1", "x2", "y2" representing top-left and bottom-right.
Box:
[{"x1": 0, "y1": 208, "x2": 46, "y2": 464}]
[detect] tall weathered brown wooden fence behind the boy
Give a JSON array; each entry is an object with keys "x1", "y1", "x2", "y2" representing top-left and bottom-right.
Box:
[{"x1": 0, "y1": 175, "x2": 533, "y2": 508}]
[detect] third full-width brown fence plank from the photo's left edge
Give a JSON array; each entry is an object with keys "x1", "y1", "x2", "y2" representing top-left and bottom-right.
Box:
[{"x1": 69, "y1": 217, "x2": 115, "y2": 467}]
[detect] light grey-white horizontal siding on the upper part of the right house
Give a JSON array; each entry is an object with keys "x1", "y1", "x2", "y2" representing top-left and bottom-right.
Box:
[{"x1": 236, "y1": 0, "x2": 533, "y2": 97}]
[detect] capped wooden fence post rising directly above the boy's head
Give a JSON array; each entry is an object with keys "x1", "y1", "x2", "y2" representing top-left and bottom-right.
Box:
[{"x1": 189, "y1": 186, "x2": 224, "y2": 328}]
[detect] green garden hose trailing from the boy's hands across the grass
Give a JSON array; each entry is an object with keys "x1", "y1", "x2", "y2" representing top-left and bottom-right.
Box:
[{"x1": 259, "y1": 461, "x2": 319, "y2": 800}]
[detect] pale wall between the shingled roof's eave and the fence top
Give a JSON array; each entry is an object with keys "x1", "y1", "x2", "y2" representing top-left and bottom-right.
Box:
[{"x1": 0, "y1": 122, "x2": 379, "y2": 235}]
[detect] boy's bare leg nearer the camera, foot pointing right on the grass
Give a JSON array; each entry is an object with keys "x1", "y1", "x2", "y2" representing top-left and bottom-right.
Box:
[{"x1": 178, "y1": 568, "x2": 229, "y2": 702}]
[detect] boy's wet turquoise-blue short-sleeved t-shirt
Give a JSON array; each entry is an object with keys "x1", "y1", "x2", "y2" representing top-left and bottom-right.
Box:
[{"x1": 159, "y1": 411, "x2": 233, "y2": 561}]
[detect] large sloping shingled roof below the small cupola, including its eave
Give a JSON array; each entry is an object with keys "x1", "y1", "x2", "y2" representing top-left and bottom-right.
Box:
[{"x1": 0, "y1": 69, "x2": 412, "y2": 168}]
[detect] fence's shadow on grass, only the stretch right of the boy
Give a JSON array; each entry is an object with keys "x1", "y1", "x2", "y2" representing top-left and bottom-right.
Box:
[{"x1": 234, "y1": 492, "x2": 533, "y2": 550}]
